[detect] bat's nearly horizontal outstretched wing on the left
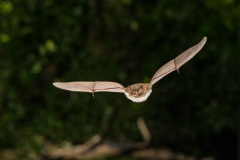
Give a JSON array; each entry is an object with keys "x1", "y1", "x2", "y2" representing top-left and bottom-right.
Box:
[{"x1": 53, "y1": 81, "x2": 125, "y2": 94}]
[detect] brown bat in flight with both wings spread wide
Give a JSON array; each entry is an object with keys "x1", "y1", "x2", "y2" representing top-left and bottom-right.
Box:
[{"x1": 53, "y1": 37, "x2": 207, "y2": 102}]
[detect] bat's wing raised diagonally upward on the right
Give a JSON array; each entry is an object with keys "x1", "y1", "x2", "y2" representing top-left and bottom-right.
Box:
[{"x1": 150, "y1": 37, "x2": 207, "y2": 86}]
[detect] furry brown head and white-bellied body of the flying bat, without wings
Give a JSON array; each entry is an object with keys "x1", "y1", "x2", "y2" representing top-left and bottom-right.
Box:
[{"x1": 125, "y1": 83, "x2": 152, "y2": 102}]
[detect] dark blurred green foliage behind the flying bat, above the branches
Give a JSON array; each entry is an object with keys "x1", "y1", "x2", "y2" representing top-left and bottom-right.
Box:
[{"x1": 0, "y1": 0, "x2": 240, "y2": 160}]
